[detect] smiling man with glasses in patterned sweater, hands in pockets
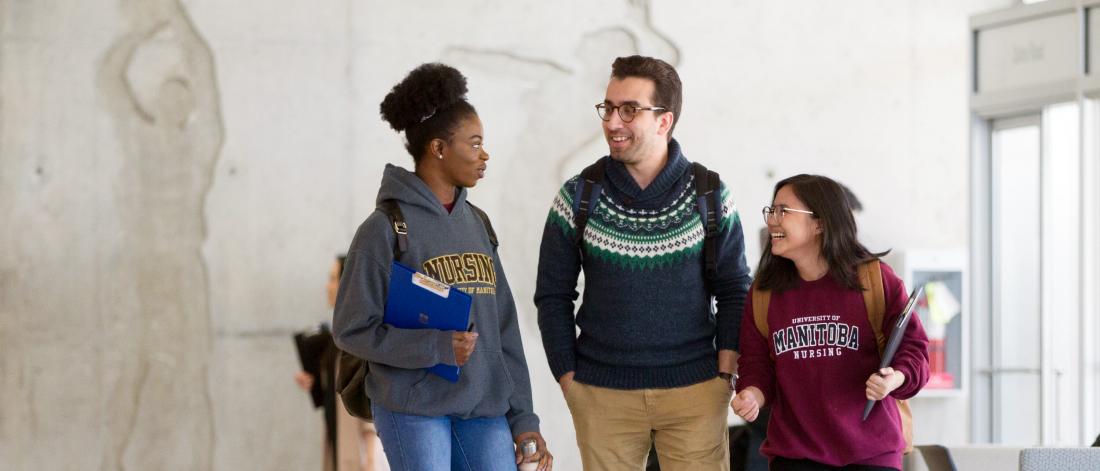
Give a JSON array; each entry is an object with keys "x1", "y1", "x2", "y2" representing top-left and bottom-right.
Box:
[{"x1": 535, "y1": 56, "x2": 750, "y2": 471}]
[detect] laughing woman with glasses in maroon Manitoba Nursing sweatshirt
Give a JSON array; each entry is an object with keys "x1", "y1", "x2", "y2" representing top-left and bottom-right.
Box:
[{"x1": 730, "y1": 175, "x2": 928, "y2": 471}]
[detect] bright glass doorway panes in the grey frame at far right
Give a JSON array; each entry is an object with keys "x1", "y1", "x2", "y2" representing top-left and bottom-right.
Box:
[{"x1": 975, "y1": 102, "x2": 1086, "y2": 446}]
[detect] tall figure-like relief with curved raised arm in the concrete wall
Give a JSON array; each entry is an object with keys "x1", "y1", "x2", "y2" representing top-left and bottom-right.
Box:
[{"x1": 97, "y1": 1, "x2": 223, "y2": 470}]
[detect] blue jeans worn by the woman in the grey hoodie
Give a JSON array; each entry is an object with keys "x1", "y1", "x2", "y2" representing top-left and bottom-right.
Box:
[{"x1": 371, "y1": 405, "x2": 516, "y2": 471}]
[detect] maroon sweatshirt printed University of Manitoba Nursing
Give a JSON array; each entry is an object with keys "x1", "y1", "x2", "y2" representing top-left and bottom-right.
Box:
[{"x1": 737, "y1": 263, "x2": 928, "y2": 469}]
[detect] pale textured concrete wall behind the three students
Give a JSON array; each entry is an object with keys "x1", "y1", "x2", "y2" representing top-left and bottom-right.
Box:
[{"x1": 0, "y1": 0, "x2": 1013, "y2": 470}]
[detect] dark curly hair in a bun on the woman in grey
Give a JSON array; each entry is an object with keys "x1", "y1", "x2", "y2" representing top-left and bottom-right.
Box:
[{"x1": 378, "y1": 63, "x2": 477, "y2": 162}]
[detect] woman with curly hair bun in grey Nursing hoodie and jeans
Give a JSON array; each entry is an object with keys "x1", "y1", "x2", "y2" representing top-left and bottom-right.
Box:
[{"x1": 332, "y1": 64, "x2": 553, "y2": 471}]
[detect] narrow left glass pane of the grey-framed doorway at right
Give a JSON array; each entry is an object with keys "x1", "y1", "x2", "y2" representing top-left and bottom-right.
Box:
[{"x1": 990, "y1": 116, "x2": 1043, "y2": 446}]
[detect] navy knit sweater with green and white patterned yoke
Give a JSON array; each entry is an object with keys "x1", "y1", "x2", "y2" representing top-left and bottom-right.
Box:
[{"x1": 535, "y1": 140, "x2": 750, "y2": 390}]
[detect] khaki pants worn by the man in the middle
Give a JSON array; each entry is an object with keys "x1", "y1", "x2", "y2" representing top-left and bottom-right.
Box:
[{"x1": 565, "y1": 377, "x2": 732, "y2": 471}]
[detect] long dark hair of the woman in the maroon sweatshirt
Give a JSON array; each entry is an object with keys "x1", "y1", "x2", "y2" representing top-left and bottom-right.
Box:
[{"x1": 756, "y1": 174, "x2": 890, "y2": 292}]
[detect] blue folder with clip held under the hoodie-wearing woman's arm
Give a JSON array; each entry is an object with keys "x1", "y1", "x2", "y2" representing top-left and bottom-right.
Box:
[{"x1": 383, "y1": 262, "x2": 473, "y2": 383}]
